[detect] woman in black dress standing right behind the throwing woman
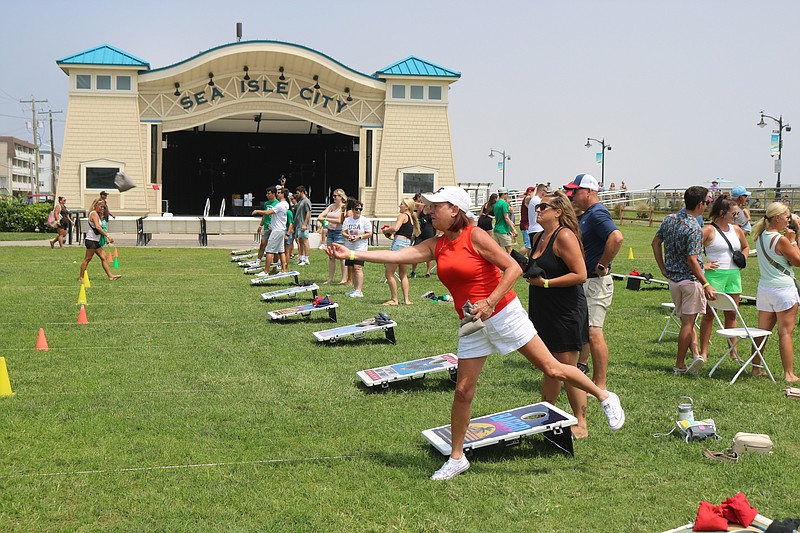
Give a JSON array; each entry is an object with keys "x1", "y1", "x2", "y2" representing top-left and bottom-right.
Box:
[{"x1": 528, "y1": 191, "x2": 589, "y2": 439}]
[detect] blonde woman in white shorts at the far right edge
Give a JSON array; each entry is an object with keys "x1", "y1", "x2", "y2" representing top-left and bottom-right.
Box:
[{"x1": 753, "y1": 202, "x2": 800, "y2": 383}]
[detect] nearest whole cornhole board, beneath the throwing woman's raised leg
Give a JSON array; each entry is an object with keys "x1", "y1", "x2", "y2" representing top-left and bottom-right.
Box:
[{"x1": 422, "y1": 402, "x2": 578, "y2": 455}]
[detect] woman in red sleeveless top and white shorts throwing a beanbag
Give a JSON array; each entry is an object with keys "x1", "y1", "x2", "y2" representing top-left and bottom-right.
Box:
[{"x1": 327, "y1": 186, "x2": 625, "y2": 481}]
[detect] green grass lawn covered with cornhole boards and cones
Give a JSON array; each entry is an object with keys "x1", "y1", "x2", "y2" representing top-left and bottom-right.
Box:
[{"x1": 0, "y1": 230, "x2": 800, "y2": 532}]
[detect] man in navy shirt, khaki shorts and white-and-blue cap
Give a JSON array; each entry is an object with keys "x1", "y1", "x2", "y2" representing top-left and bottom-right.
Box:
[{"x1": 564, "y1": 174, "x2": 622, "y2": 389}]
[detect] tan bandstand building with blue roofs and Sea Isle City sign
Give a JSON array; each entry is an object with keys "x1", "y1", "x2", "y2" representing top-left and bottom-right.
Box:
[{"x1": 57, "y1": 41, "x2": 460, "y2": 217}]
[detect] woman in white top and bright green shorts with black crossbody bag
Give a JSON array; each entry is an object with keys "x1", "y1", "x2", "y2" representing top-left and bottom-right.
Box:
[{"x1": 700, "y1": 194, "x2": 750, "y2": 359}]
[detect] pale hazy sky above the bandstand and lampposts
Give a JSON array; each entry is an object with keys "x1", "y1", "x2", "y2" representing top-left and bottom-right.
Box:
[{"x1": 0, "y1": 0, "x2": 800, "y2": 189}]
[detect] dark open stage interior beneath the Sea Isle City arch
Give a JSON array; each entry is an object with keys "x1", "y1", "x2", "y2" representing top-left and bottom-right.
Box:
[{"x1": 162, "y1": 130, "x2": 358, "y2": 215}]
